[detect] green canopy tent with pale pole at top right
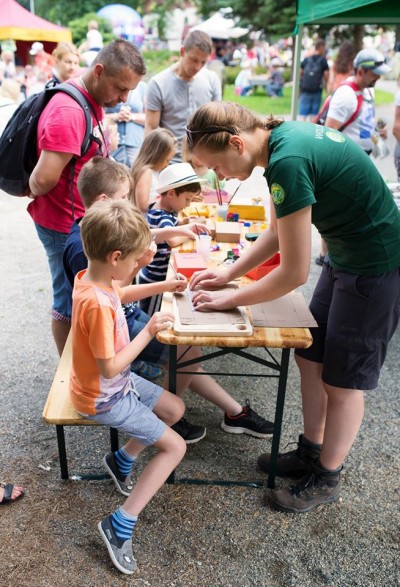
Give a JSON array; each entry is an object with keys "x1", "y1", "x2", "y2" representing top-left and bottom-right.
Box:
[{"x1": 291, "y1": 0, "x2": 400, "y2": 120}]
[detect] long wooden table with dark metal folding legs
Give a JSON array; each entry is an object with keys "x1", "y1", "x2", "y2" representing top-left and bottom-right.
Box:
[{"x1": 157, "y1": 232, "x2": 312, "y2": 488}]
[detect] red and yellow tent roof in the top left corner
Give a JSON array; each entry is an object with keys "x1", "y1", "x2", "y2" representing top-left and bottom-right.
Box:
[{"x1": 0, "y1": 0, "x2": 72, "y2": 43}]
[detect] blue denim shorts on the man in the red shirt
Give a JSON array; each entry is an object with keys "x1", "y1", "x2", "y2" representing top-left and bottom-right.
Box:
[{"x1": 35, "y1": 223, "x2": 71, "y2": 323}]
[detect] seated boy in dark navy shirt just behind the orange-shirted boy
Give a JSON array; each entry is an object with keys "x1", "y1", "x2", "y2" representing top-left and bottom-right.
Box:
[{"x1": 64, "y1": 157, "x2": 273, "y2": 444}]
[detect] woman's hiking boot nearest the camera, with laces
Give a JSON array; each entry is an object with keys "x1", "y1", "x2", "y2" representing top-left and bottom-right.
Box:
[{"x1": 272, "y1": 461, "x2": 341, "y2": 514}]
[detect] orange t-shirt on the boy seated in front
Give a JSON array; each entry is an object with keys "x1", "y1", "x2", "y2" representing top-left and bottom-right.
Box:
[{"x1": 70, "y1": 270, "x2": 132, "y2": 415}]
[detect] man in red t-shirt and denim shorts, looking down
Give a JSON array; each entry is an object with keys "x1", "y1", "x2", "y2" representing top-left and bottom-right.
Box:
[{"x1": 28, "y1": 39, "x2": 146, "y2": 355}]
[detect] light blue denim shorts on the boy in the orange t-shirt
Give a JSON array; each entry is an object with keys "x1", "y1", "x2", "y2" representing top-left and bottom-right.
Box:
[{"x1": 82, "y1": 373, "x2": 166, "y2": 446}]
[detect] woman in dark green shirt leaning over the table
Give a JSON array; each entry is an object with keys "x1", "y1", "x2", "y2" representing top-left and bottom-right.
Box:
[{"x1": 187, "y1": 102, "x2": 400, "y2": 512}]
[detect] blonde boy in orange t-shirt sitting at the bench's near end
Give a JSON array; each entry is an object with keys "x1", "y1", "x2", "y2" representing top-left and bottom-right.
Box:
[{"x1": 70, "y1": 200, "x2": 186, "y2": 574}]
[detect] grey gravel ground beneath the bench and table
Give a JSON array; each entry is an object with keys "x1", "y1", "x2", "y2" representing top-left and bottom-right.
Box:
[{"x1": 0, "y1": 99, "x2": 400, "y2": 587}]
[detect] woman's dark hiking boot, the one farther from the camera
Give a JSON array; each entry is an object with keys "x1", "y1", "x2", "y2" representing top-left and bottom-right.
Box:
[{"x1": 257, "y1": 434, "x2": 322, "y2": 478}]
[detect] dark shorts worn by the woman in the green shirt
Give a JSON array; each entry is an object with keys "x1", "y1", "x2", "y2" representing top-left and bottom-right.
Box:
[{"x1": 296, "y1": 261, "x2": 400, "y2": 390}]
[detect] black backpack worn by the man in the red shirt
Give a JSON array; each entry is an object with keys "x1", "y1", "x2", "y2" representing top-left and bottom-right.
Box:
[{"x1": 0, "y1": 83, "x2": 101, "y2": 196}]
